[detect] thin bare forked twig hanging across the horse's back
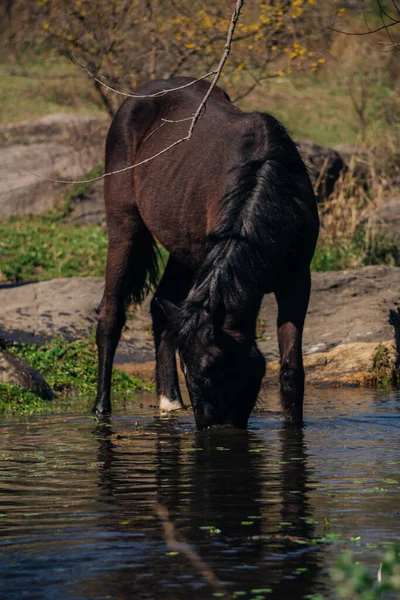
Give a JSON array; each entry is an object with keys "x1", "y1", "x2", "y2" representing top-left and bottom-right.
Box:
[{"x1": 26, "y1": 0, "x2": 244, "y2": 183}]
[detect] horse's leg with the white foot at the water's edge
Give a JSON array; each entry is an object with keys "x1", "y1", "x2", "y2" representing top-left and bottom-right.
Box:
[{"x1": 151, "y1": 257, "x2": 190, "y2": 411}]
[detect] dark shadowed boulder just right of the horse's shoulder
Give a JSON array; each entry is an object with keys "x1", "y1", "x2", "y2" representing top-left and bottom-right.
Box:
[{"x1": 298, "y1": 140, "x2": 347, "y2": 201}]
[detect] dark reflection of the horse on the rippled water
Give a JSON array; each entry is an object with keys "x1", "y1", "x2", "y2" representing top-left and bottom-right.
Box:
[{"x1": 72, "y1": 427, "x2": 318, "y2": 600}]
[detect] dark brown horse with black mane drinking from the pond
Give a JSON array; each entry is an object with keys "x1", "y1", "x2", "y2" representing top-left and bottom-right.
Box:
[{"x1": 93, "y1": 78, "x2": 319, "y2": 429}]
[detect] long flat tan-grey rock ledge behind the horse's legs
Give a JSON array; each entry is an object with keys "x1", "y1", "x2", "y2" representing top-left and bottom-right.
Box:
[{"x1": 0, "y1": 266, "x2": 400, "y2": 370}]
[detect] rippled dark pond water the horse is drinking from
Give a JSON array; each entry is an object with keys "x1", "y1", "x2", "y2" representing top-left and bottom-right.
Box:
[{"x1": 0, "y1": 389, "x2": 400, "y2": 600}]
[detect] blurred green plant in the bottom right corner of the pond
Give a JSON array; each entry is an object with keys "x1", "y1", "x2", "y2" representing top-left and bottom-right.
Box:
[{"x1": 332, "y1": 544, "x2": 400, "y2": 600}]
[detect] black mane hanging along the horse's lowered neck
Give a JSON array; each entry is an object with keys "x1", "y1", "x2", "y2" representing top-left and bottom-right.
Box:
[{"x1": 174, "y1": 115, "x2": 307, "y2": 342}]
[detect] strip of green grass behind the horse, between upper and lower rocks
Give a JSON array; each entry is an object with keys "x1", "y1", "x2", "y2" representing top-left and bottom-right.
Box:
[{"x1": 0, "y1": 206, "x2": 400, "y2": 283}]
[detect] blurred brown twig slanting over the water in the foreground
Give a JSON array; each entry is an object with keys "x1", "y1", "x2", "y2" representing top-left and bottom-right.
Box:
[{"x1": 155, "y1": 502, "x2": 224, "y2": 591}]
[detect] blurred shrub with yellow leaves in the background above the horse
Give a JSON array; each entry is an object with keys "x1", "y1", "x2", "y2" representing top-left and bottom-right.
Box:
[{"x1": 0, "y1": 0, "x2": 332, "y2": 114}]
